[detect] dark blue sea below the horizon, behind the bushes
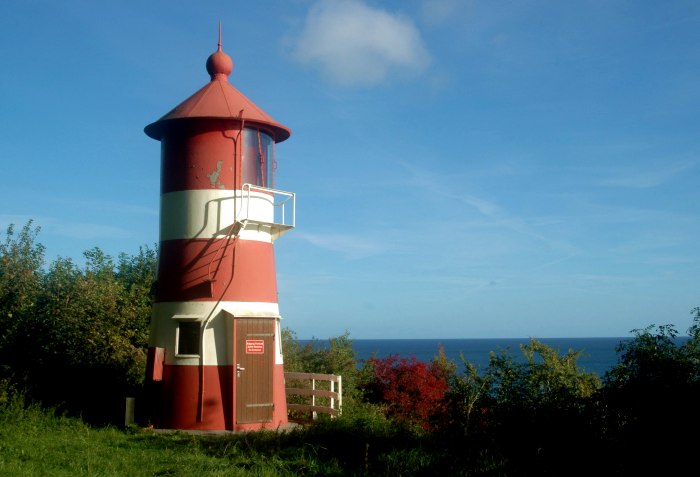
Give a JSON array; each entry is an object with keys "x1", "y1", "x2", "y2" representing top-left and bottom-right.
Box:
[{"x1": 299, "y1": 337, "x2": 687, "y2": 377}]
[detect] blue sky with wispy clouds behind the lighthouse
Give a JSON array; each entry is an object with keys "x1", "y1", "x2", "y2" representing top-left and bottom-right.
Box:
[{"x1": 0, "y1": 0, "x2": 700, "y2": 339}]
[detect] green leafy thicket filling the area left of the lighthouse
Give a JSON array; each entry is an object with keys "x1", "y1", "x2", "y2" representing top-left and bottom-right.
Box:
[{"x1": 0, "y1": 222, "x2": 156, "y2": 422}]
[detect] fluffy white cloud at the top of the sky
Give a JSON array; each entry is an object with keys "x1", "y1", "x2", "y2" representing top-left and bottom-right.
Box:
[{"x1": 294, "y1": 0, "x2": 430, "y2": 86}]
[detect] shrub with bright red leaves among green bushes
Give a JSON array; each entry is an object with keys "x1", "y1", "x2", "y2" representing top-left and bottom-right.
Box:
[{"x1": 368, "y1": 355, "x2": 448, "y2": 429}]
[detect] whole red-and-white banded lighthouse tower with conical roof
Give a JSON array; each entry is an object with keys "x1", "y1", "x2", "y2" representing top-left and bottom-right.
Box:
[{"x1": 144, "y1": 29, "x2": 295, "y2": 431}]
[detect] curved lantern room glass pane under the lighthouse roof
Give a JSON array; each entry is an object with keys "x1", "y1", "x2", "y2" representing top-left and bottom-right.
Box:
[{"x1": 243, "y1": 128, "x2": 275, "y2": 188}]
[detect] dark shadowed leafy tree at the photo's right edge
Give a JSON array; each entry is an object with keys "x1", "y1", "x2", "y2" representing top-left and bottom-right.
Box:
[{"x1": 601, "y1": 308, "x2": 700, "y2": 475}]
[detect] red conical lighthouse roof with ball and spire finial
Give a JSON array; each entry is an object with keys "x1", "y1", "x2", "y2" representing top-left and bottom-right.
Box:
[{"x1": 144, "y1": 36, "x2": 291, "y2": 142}]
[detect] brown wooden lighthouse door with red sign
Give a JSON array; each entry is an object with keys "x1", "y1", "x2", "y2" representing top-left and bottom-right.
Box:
[{"x1": 234, "y1": 318, "x2": 275, "y2": 424}]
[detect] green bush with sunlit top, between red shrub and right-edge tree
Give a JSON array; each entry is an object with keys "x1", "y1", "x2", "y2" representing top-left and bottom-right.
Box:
[{"x1": 441, "y1": 339, "x2": 601, "y2": 475}]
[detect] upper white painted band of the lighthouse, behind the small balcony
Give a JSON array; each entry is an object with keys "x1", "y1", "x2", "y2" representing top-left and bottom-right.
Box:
[{"x1": 160, "y1": 189, "x2": 274, "y2": 242}]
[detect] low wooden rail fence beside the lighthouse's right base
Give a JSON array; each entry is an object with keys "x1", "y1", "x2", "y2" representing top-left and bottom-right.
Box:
[{"x1": 284, "y1": 372, "x2": 343, "y2": 420}]
